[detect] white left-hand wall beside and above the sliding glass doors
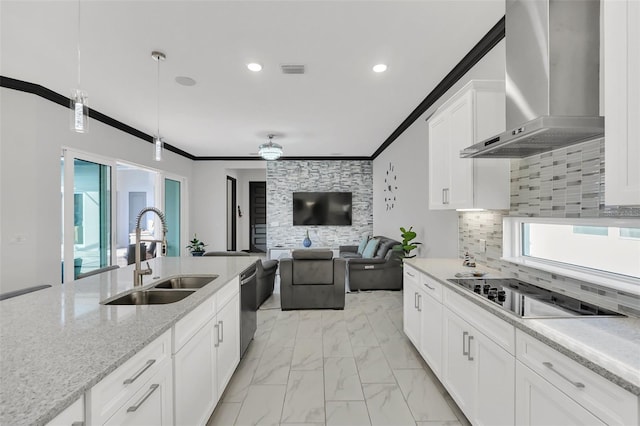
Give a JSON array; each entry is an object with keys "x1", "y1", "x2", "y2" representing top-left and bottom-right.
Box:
[{"x1": 0, "y1": 88, "x2": 194, "y2": 292}]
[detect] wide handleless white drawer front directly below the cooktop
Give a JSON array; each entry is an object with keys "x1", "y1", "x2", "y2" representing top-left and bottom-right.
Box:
[{"x1": 443, "y1": 289, "x2": 516, "y2": 355}]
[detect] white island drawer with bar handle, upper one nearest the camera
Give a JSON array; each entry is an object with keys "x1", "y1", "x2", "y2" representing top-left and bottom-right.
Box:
[{"x1": 89, "y1": 330, "x2": 171, "y2": 424}]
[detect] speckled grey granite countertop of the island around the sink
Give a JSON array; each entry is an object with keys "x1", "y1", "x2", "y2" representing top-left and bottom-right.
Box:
[{"x1": 0, "y1": 256, "x2": 257, "y2": 426}]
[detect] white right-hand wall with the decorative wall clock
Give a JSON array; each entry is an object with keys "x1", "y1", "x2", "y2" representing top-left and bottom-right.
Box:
[{"x1": 373, "y1": 40, "x2": 505, "y2": 258}]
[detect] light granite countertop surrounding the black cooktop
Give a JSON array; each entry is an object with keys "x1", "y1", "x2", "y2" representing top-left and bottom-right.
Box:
[{"x1": 405, "y1": 258, "x2": 640, "y2": 396}]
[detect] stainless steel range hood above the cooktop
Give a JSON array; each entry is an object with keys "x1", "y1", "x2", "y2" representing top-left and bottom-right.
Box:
[{"x1": 460, "y1": 0, "x2": 604, "y2": 158}]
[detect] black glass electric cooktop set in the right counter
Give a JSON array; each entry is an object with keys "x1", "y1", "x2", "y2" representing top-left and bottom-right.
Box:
[{"x1": 447, "y1": 278, "x2": 624, "y2": 318}]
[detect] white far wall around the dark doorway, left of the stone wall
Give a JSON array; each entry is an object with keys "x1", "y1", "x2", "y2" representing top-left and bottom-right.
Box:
[{"x1": 189, "y1": 161, "x2": 266, "y2": 251}]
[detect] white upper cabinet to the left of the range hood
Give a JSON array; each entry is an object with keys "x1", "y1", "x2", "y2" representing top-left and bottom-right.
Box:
[{"x1": 429, "y1": 80, "x2": 510, "y2": 209}]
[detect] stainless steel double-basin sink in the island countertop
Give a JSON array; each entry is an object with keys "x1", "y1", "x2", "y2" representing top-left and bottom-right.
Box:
[{"x1": 104, "y1": 275, "x2": 218, "y2": 305}]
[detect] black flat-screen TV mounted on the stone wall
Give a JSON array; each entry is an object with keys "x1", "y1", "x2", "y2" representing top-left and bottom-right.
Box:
[{"x1": 293, "y1": 192, "x2": 351, "y2": 226}]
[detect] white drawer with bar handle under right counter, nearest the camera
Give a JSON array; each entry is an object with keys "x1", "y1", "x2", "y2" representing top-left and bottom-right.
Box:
[{"x1": 516, "y1": 330, "x2": 639, "y2": 425}]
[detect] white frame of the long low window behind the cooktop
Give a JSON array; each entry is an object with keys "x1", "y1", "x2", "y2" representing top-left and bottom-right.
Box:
[{"x1": 500, "y1": 217, "x2": 640, "y2": 295}]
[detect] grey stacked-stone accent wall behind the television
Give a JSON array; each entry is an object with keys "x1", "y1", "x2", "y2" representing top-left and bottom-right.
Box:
[{"x1": 267, "y1": 160, "x2": 373, "y2": 248}]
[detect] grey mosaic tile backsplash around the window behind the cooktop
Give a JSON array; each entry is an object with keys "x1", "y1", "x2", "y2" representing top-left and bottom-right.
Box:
[{"x1": 458, "y1": 139, "x2": 640, "y2": 317}]
